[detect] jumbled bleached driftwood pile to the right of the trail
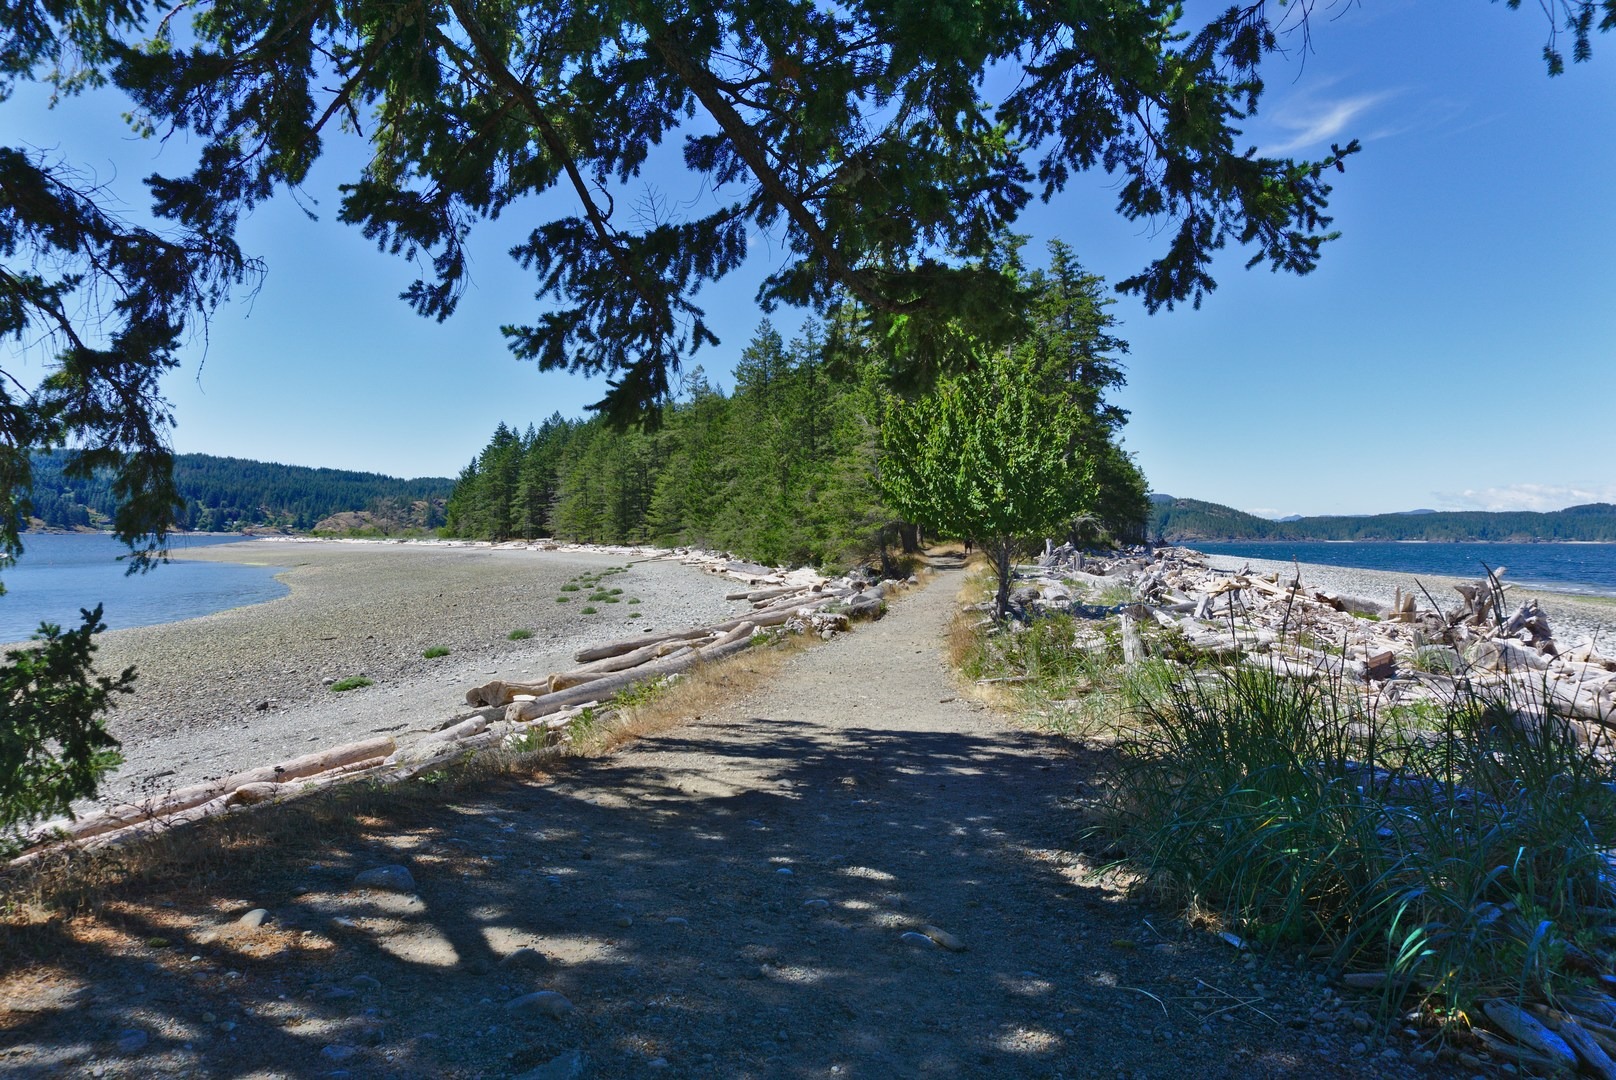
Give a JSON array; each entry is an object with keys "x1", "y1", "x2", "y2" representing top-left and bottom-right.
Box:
[{"x1": 1012, "y1": 548, "x2": 1616, "y2": 745}]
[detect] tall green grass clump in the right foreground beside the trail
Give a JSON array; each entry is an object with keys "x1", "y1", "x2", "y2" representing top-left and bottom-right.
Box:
[{"x1": 1100, "y1": 668, "x2": 1616, "y2": 1009}]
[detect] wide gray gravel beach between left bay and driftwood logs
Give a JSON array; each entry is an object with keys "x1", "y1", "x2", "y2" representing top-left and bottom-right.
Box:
[{"x1": 83, "y1": 540, "x2": 747, "y2": 802}]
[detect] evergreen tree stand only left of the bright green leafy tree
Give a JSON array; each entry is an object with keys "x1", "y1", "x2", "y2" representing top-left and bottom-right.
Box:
[{"x1": 444, "y1": 323, "x2": 892, "y2": 564}]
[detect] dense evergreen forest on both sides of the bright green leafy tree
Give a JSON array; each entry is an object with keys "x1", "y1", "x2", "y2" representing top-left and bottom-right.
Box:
[{"x1": 444, "y1": 244, "x2": 1147, "y2": 566}]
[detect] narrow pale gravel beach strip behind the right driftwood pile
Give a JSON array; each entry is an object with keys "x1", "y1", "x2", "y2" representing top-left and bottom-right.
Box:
[{"x1": 1202, "y1": 555, "x2": 1616, "y2": 656}]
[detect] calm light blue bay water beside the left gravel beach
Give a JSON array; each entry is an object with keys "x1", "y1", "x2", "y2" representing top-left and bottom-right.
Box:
[{"x1": 0, "y1": 534, "x2": 288, "y2": 642}]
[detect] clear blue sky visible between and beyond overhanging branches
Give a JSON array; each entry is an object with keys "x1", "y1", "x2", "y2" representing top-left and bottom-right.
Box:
[{"x1": 0, "y1": 0, "x2": 1616, "y2": 516}]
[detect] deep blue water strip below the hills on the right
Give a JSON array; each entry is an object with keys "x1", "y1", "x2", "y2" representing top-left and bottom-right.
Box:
[{"x1": 1186, "y1": 540, "x2": 1616, "y2": 597}]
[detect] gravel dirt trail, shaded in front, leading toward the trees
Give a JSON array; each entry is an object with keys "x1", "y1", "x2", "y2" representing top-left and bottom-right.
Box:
[{"x1": 0, "y1": 571, "x2": 1474, "y2": 1080}]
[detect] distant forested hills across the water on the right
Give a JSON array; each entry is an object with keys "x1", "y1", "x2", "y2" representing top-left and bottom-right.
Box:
[{"x1": 1151, "y1": 495, "x2": 1616, "y2": 543}]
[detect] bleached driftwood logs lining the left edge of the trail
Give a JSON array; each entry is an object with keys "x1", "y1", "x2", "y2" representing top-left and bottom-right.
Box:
[{"x1": 10, "y1": 542, "x2": 895, "y2": 867}]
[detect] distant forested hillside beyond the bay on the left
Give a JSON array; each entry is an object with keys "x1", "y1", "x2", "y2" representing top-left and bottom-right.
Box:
[{"x1": 31, "y1": 453, "x2": 454, "y2": 534}]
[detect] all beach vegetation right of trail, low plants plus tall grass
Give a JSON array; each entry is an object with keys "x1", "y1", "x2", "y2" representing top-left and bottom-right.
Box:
[{"x1": 950, "y1": 556, "x2": 1616, "y2": 1027}]
